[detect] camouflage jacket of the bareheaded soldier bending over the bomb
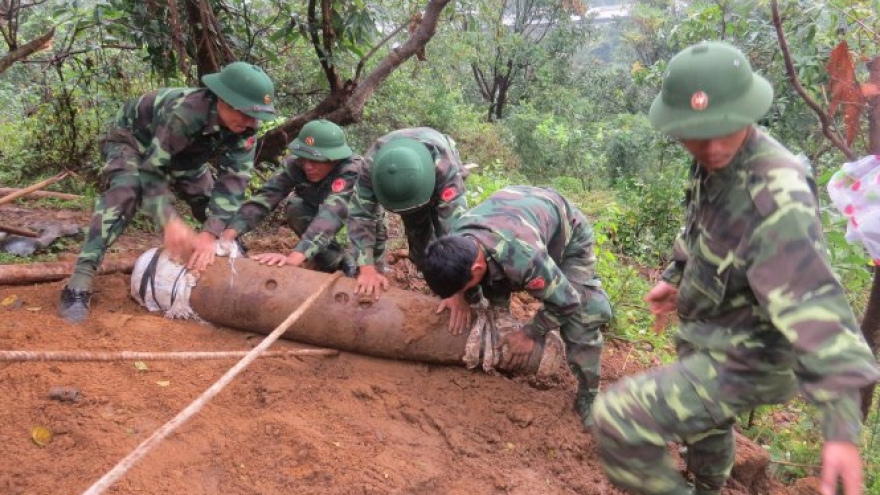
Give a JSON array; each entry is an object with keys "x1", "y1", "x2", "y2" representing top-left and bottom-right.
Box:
[{"x1": 450, "y1": 186, "x2": 593, "y2": 334}]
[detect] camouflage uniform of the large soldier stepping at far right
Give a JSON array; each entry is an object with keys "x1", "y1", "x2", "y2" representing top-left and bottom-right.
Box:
[{"x1": 594, "y1": 129, "x2": 878, "y2": 495}]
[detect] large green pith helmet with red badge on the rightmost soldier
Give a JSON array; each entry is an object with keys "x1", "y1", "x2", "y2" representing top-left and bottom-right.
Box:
[{"x1": 648, "y1": 41, "x2": 773, "y2": 139}]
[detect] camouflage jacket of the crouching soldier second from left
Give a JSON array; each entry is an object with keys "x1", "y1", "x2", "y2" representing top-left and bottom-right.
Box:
[{"x1": 229, "y1": 155, "x2": 363, "y2": 259}]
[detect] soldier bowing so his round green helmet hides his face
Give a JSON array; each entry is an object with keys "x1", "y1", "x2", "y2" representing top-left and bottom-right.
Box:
[{"x1": 348, "y1": 127, "x2": 470, "y2": 306}]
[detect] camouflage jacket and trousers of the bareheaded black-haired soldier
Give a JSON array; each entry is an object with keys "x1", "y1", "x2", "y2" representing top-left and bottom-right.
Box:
[{"x1": 450, "y1": 186, "x2": 612, "y2": 419}]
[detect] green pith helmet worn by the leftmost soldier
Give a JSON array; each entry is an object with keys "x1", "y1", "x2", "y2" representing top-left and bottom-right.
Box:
[{"x1": 202, "y1": 62, "x2": 275, "y2": 120}]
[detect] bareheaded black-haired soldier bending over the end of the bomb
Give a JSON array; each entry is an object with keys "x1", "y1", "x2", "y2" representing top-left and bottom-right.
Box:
[{"x1": 422, "y1": 186, "x2": 612, "y2": 428}]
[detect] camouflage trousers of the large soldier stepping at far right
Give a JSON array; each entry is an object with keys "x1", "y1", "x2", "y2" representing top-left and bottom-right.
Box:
[{"x1": 593, "y1": 341, "x2": 797, "y2": 495}]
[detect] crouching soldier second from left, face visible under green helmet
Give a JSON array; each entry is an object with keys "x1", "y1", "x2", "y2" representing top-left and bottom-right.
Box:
[{"x1": 222, "y1": 119, "x2": 387, "y2": 277}]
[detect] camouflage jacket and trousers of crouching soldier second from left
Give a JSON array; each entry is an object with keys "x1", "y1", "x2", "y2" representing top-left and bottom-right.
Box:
[{"x1": 229, "y1": 155, "x2": 387, "y2": 272}]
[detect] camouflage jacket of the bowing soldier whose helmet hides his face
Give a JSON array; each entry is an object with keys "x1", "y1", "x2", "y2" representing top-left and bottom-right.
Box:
[{"x1": 348, "y1": 127, "x2": 467, "y2": 266}]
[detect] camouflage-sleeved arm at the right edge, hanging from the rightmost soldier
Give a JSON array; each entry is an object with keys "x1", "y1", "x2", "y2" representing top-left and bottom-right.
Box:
[{"x1": 747, "y1": 168, "x2": 878, "y2": 443}]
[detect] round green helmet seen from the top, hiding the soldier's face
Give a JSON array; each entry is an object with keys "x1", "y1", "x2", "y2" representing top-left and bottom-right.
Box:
[{"x1": 370, "y1": 138, "x2": 437, "y2": 213}]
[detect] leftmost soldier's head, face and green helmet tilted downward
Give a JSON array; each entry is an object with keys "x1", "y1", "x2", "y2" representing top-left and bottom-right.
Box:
[{"x1": 202, "y1": 62, "x2": 275, "y2": 134}]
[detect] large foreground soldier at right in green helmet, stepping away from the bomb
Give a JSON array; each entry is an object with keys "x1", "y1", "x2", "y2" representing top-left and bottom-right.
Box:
[{"x1": 593, "y1": 42, "x2": 878, "y2": 495}]
